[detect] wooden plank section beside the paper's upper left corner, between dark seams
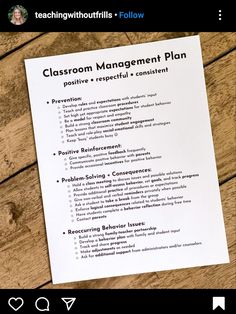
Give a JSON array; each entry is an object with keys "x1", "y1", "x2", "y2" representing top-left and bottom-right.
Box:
[{"x1": 0, "y1": 33, "x2": 129, "y2": 182}]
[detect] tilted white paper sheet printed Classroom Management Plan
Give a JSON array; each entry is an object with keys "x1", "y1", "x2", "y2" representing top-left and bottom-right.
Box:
[{"x1": 25, "y1": 36, "x2": 229, "y2": 283}]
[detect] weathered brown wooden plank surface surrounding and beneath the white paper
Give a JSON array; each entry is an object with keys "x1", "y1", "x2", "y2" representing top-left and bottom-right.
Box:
[{"x1": 0, "y1": 33, "x2": 236, "y2": 288}]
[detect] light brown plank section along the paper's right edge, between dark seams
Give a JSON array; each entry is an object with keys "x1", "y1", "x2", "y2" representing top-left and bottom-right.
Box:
[{"x1": 205, "y1": 51, "x2": 236, "y2": 182}]
